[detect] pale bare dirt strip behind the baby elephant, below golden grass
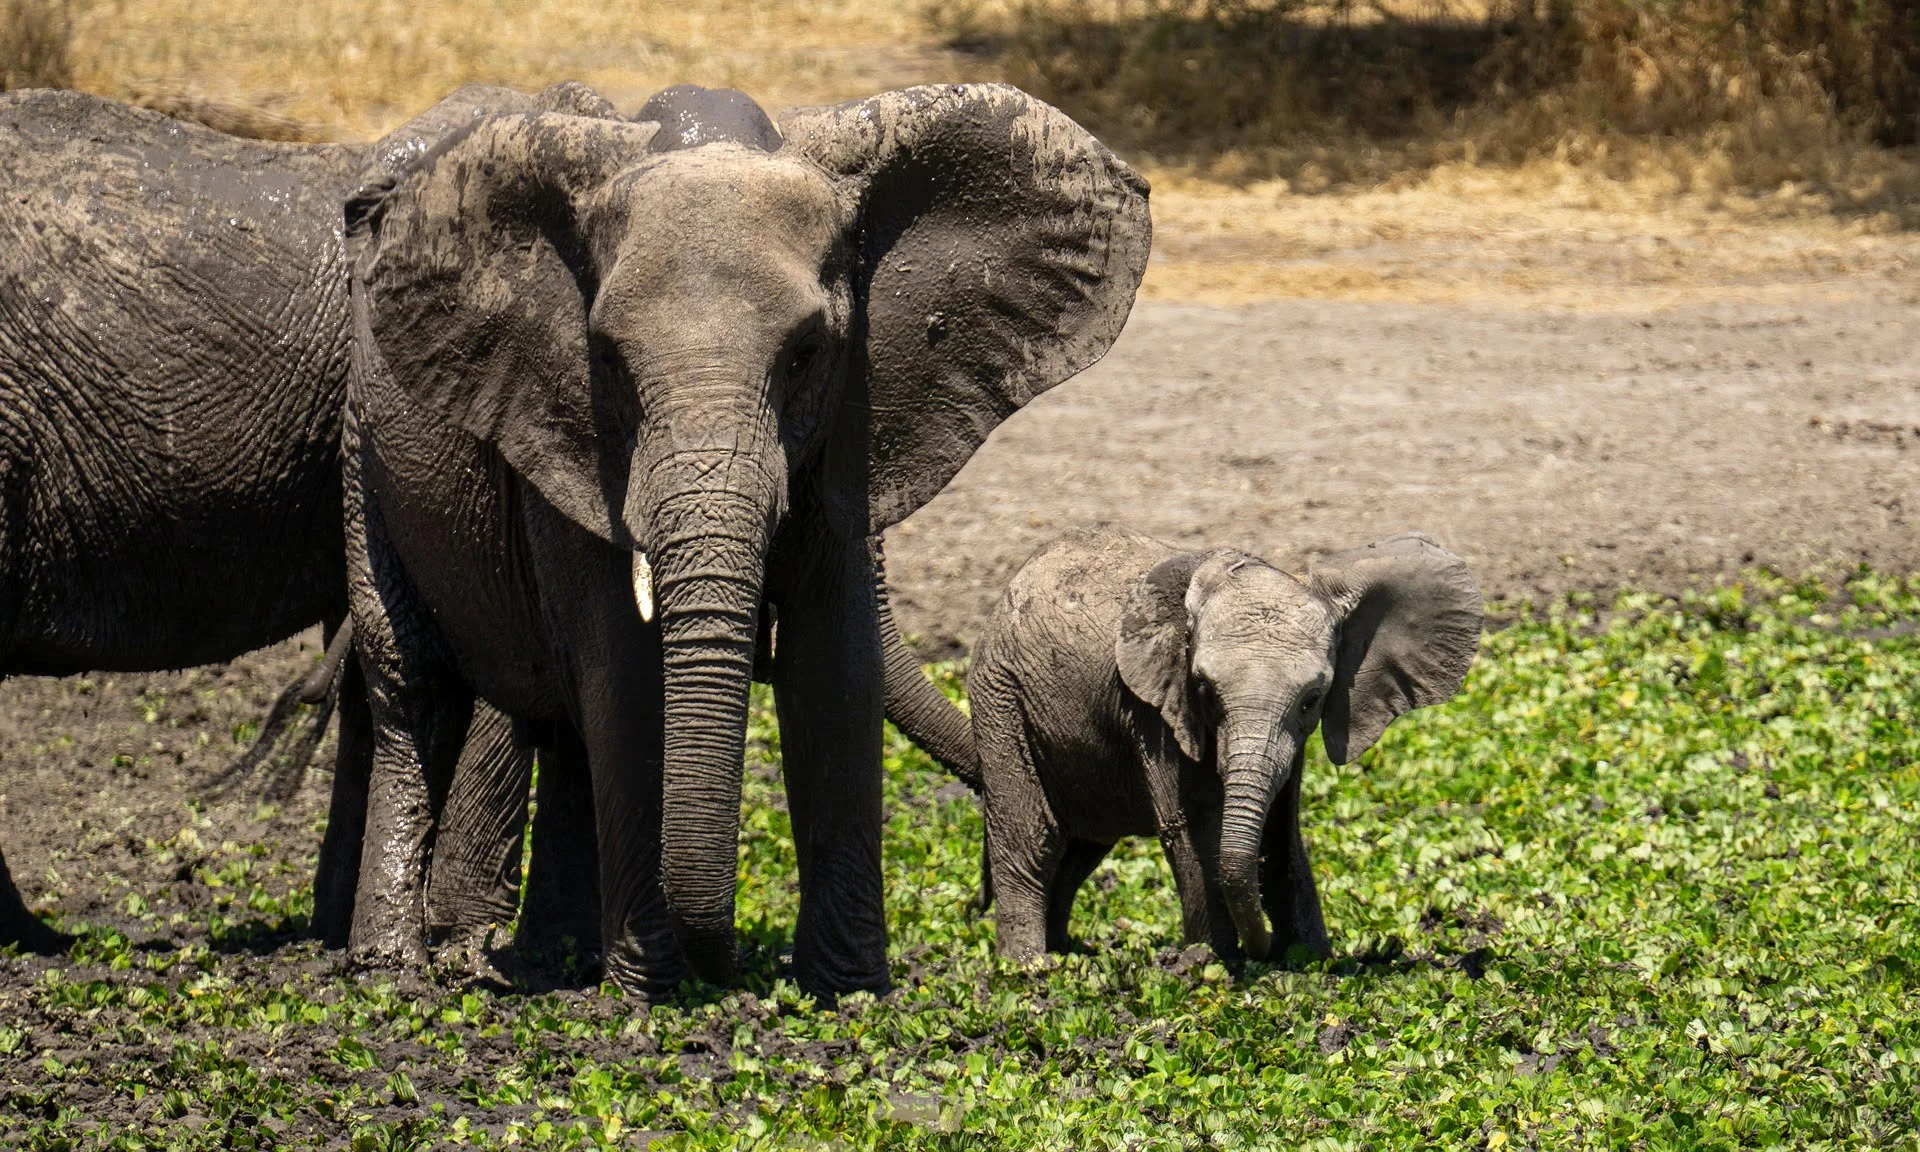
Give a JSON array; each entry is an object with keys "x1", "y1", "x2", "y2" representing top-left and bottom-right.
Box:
[{"x1": 887, "y1": 227, "x2": 1920, "y2": 655}]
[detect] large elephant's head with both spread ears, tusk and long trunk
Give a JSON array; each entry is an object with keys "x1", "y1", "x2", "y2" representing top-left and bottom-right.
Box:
[{"x1": 348, "y1": 84, "x2": 1150, "y2": 979}]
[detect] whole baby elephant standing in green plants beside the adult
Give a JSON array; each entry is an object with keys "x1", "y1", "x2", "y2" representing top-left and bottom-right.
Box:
[{"x1": 968, "y1": 528, "x2": 1482, "y2": 960}]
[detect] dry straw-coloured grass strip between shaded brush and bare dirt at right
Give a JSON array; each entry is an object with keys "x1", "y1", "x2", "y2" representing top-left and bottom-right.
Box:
[{"x1": 1142, "y1": 161, "x2": 1920, "y2": 311}]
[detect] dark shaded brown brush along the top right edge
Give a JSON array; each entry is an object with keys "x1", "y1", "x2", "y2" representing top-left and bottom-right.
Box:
[{"x1": 935, "y1": 0, "x2": 1920, "y2": 215}]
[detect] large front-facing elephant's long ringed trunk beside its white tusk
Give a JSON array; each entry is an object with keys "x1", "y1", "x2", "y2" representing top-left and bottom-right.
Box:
[{"x1": 636, "y1": 440, "x2": 785, "y2": 983}]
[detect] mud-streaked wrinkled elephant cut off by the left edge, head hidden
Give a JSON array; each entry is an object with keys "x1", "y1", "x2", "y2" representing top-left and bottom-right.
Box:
[{"x1": 0, "y1": 86, "x2": 606, "y2": 948}]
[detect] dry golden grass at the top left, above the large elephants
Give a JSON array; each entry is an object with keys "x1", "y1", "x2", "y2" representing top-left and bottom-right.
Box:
[{"x1": 61, "y1": 0, "x2": 975, "y2": 138}]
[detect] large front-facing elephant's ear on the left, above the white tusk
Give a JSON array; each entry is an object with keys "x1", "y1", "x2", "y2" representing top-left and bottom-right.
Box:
[{"x1": 348, "y1": 113, "x2": 655, "y2": 545}]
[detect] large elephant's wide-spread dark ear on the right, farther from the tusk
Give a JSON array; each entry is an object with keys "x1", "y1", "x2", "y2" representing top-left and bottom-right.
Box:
[{"x1": 780, "y1": 84, "x2": 1152, "y2": 530}]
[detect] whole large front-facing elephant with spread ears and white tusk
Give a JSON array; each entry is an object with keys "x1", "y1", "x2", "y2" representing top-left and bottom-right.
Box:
[{"x1": 346, "y1": 86, "x2": 1150, "y2": 996}]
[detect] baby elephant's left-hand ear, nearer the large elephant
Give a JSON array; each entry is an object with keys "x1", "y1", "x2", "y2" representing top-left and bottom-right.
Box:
[{"x1": 1114, "y1": 553, "x2": 1208, "y2": 760}]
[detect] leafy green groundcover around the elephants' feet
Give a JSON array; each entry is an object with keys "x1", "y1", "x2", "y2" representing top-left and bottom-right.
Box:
[{"x1": 0, "y1": 572, "x2": 1920, "y2": 1150}]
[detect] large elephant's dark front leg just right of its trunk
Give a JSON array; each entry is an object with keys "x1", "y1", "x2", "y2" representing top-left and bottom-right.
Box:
[{"x1": 774, "y1": 534, "x2": 889, "y2": 996}]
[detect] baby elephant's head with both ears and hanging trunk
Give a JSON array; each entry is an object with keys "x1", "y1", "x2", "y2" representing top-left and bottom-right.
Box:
[{"x1": 1116, "y1": 532, "x2": 1482, "y2": 960}]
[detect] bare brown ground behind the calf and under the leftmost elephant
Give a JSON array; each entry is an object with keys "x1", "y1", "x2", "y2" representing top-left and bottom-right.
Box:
[{"x1": 0, "y1": 290, "x2": 1920, "y2": 1136}]
